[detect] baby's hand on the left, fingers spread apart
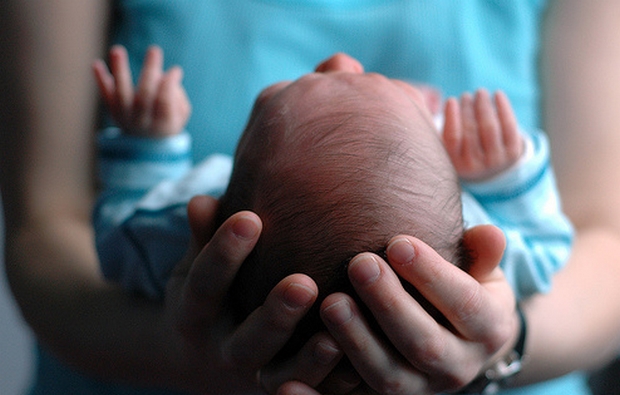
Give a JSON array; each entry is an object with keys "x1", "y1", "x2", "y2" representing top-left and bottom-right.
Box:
[{"x1": 93, "y1": 45, "x2": 191, "y2": 137}]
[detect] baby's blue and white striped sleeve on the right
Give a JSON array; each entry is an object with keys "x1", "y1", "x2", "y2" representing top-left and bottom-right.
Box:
[{"x1": 462, "y1": 131, "x2": 573, "y2": 298}]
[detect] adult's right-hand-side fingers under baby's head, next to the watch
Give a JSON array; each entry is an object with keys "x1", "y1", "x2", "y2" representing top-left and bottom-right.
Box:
[{"x1": 334, "y1": 226, "x2": 515, "y2": 392}]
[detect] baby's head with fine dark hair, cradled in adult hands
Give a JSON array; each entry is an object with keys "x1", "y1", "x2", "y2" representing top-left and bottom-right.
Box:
[{"x1": 219, "y1": 60, "x2": 463, "y2": 360}]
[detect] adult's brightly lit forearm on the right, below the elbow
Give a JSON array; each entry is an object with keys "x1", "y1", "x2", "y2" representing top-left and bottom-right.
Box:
[{"x1": 517, "y1": 229, "x2": 620, "y2": 384}]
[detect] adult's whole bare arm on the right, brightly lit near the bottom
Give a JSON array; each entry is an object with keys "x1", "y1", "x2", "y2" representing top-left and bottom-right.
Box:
[{"x1": 520, "y1": 0, "x2": 620, "y2": 381}]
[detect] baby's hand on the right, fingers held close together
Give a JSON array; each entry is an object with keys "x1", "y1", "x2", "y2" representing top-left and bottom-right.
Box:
[{"x1": 443, "y1": 89, "x2": 524, "y2": 182}]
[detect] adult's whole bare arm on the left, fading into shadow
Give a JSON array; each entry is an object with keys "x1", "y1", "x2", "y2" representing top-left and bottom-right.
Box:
[{"x1": 0, "y1": 1, "x2": 194, "y2": 382}]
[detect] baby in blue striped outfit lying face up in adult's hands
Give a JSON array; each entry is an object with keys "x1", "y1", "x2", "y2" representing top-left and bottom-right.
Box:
[{"x1": 95, "y1": 48, "x2": 572, "y2": 337}]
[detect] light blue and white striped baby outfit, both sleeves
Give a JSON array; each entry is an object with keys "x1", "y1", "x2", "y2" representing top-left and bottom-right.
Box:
[{"x1": 94, "y1": 128, "x2": 572, "y2": 299}]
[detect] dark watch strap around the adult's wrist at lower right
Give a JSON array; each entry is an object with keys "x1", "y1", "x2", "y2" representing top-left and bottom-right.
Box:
[{"x1": 457, "y1": 305, "x2": 527, "y2": 395}]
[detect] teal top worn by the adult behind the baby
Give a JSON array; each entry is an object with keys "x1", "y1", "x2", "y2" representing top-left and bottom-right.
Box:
[{"x1": 32, "y1": 0, "x2": 589, "y2": 395}]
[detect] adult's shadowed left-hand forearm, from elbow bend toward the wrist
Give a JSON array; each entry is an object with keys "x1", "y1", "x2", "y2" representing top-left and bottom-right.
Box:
[{"x1": 7, "y1": 215, "x2": 191, "y2": 384}]
